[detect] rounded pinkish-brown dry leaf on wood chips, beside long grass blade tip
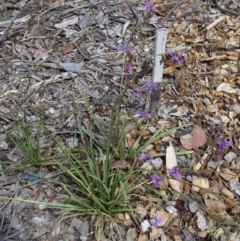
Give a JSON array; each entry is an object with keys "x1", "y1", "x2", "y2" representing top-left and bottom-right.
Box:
[{"x1": 180, "y1": 126, "x2": 207, "y2": 151}]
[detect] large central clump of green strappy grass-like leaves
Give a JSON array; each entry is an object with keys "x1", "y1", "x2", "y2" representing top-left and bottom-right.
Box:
[{"x1": 49, "y1": 87, "x2": 142, "y2": 218}]
